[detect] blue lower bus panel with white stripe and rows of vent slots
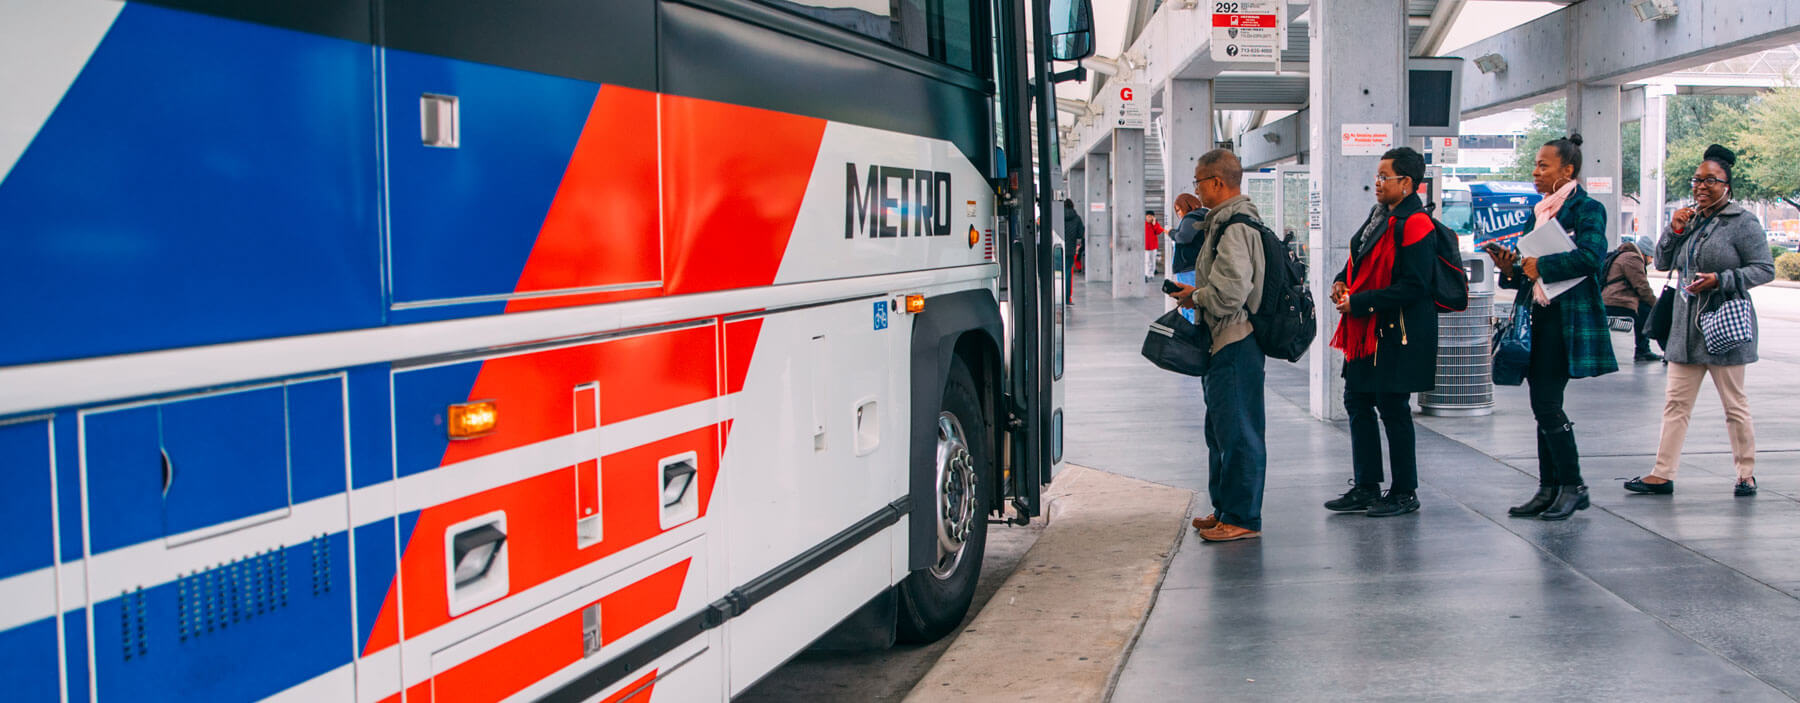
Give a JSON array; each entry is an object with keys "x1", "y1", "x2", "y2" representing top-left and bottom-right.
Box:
[{"x1": 77, "y1": 374, "x2": 356, "y2": 699}]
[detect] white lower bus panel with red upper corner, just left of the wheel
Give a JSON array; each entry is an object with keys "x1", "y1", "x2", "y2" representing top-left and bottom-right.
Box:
[{"x1": 722, "y1": 297, "x2": 911, "y2": 694}]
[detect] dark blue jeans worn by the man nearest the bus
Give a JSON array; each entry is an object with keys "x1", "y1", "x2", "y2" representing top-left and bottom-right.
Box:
[{"x1": 1201, "y1": 338, "x2": 1269, "y2": 532}]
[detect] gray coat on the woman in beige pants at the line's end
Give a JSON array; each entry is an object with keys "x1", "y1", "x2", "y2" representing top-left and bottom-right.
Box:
[{"x1": 1656, "y1": 203, "x2": 1775, "y2": 367}]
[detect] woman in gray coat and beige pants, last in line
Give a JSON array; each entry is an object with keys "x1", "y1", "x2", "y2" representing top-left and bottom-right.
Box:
[{"x1": 1625, "y1": 144, "x2": 1775, "y2": 496}]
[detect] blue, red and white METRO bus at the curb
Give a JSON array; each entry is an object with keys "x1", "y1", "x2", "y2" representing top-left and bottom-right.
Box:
[{"x1": 0, "y1": 0, "x2": 1093, "y2": 701}]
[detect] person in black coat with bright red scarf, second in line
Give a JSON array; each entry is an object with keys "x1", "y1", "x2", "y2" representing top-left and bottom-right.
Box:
[{"x1": 1325, "y1": 146, "x2": 1438, "y2": 518}]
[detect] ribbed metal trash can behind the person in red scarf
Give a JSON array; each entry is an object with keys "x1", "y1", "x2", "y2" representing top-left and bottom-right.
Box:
[{"x1": 1418, "y1": 257, "x2": 1494, "y2": 417}]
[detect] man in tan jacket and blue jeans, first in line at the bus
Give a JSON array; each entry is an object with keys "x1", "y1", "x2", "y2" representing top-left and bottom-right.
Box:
[{"x1": 1170, "y1": 149, "x2": 1269, "y2": 541}]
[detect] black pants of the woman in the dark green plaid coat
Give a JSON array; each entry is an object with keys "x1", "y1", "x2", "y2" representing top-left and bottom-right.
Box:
[{"x1": 1525, "y1": 302, "x2": 1582, "y2": 485}]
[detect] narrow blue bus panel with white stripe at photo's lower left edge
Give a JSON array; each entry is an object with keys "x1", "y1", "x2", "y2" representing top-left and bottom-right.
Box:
[{"x1": 0, "y1": 419, "x2": 61, "y2": 701}]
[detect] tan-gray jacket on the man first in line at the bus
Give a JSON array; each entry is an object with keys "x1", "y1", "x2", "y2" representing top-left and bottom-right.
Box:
[{"x1": 1193, "y1": 196, "x2": 1274, "y2": 352}]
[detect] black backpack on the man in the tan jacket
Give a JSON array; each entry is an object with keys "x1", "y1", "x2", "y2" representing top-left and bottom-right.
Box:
[{"x1": 1213, "y1": 212, "x2": 1317, "y2": 361}]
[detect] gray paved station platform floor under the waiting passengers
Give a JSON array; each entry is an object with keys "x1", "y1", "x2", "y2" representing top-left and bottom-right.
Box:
[{"x1": 1066, "y1": 278, "x2": 1800, "y2": 701}]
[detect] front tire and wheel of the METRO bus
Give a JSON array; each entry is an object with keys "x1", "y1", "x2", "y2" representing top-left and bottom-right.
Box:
[{"x1": 896, "y1": 356, "x2": 994, "y2": 644}]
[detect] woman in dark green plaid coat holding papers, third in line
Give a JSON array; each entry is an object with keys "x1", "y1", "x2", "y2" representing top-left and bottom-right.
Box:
[{"x1": 1489, "y1": 135, "x2": 1618, "y2": 520}]
